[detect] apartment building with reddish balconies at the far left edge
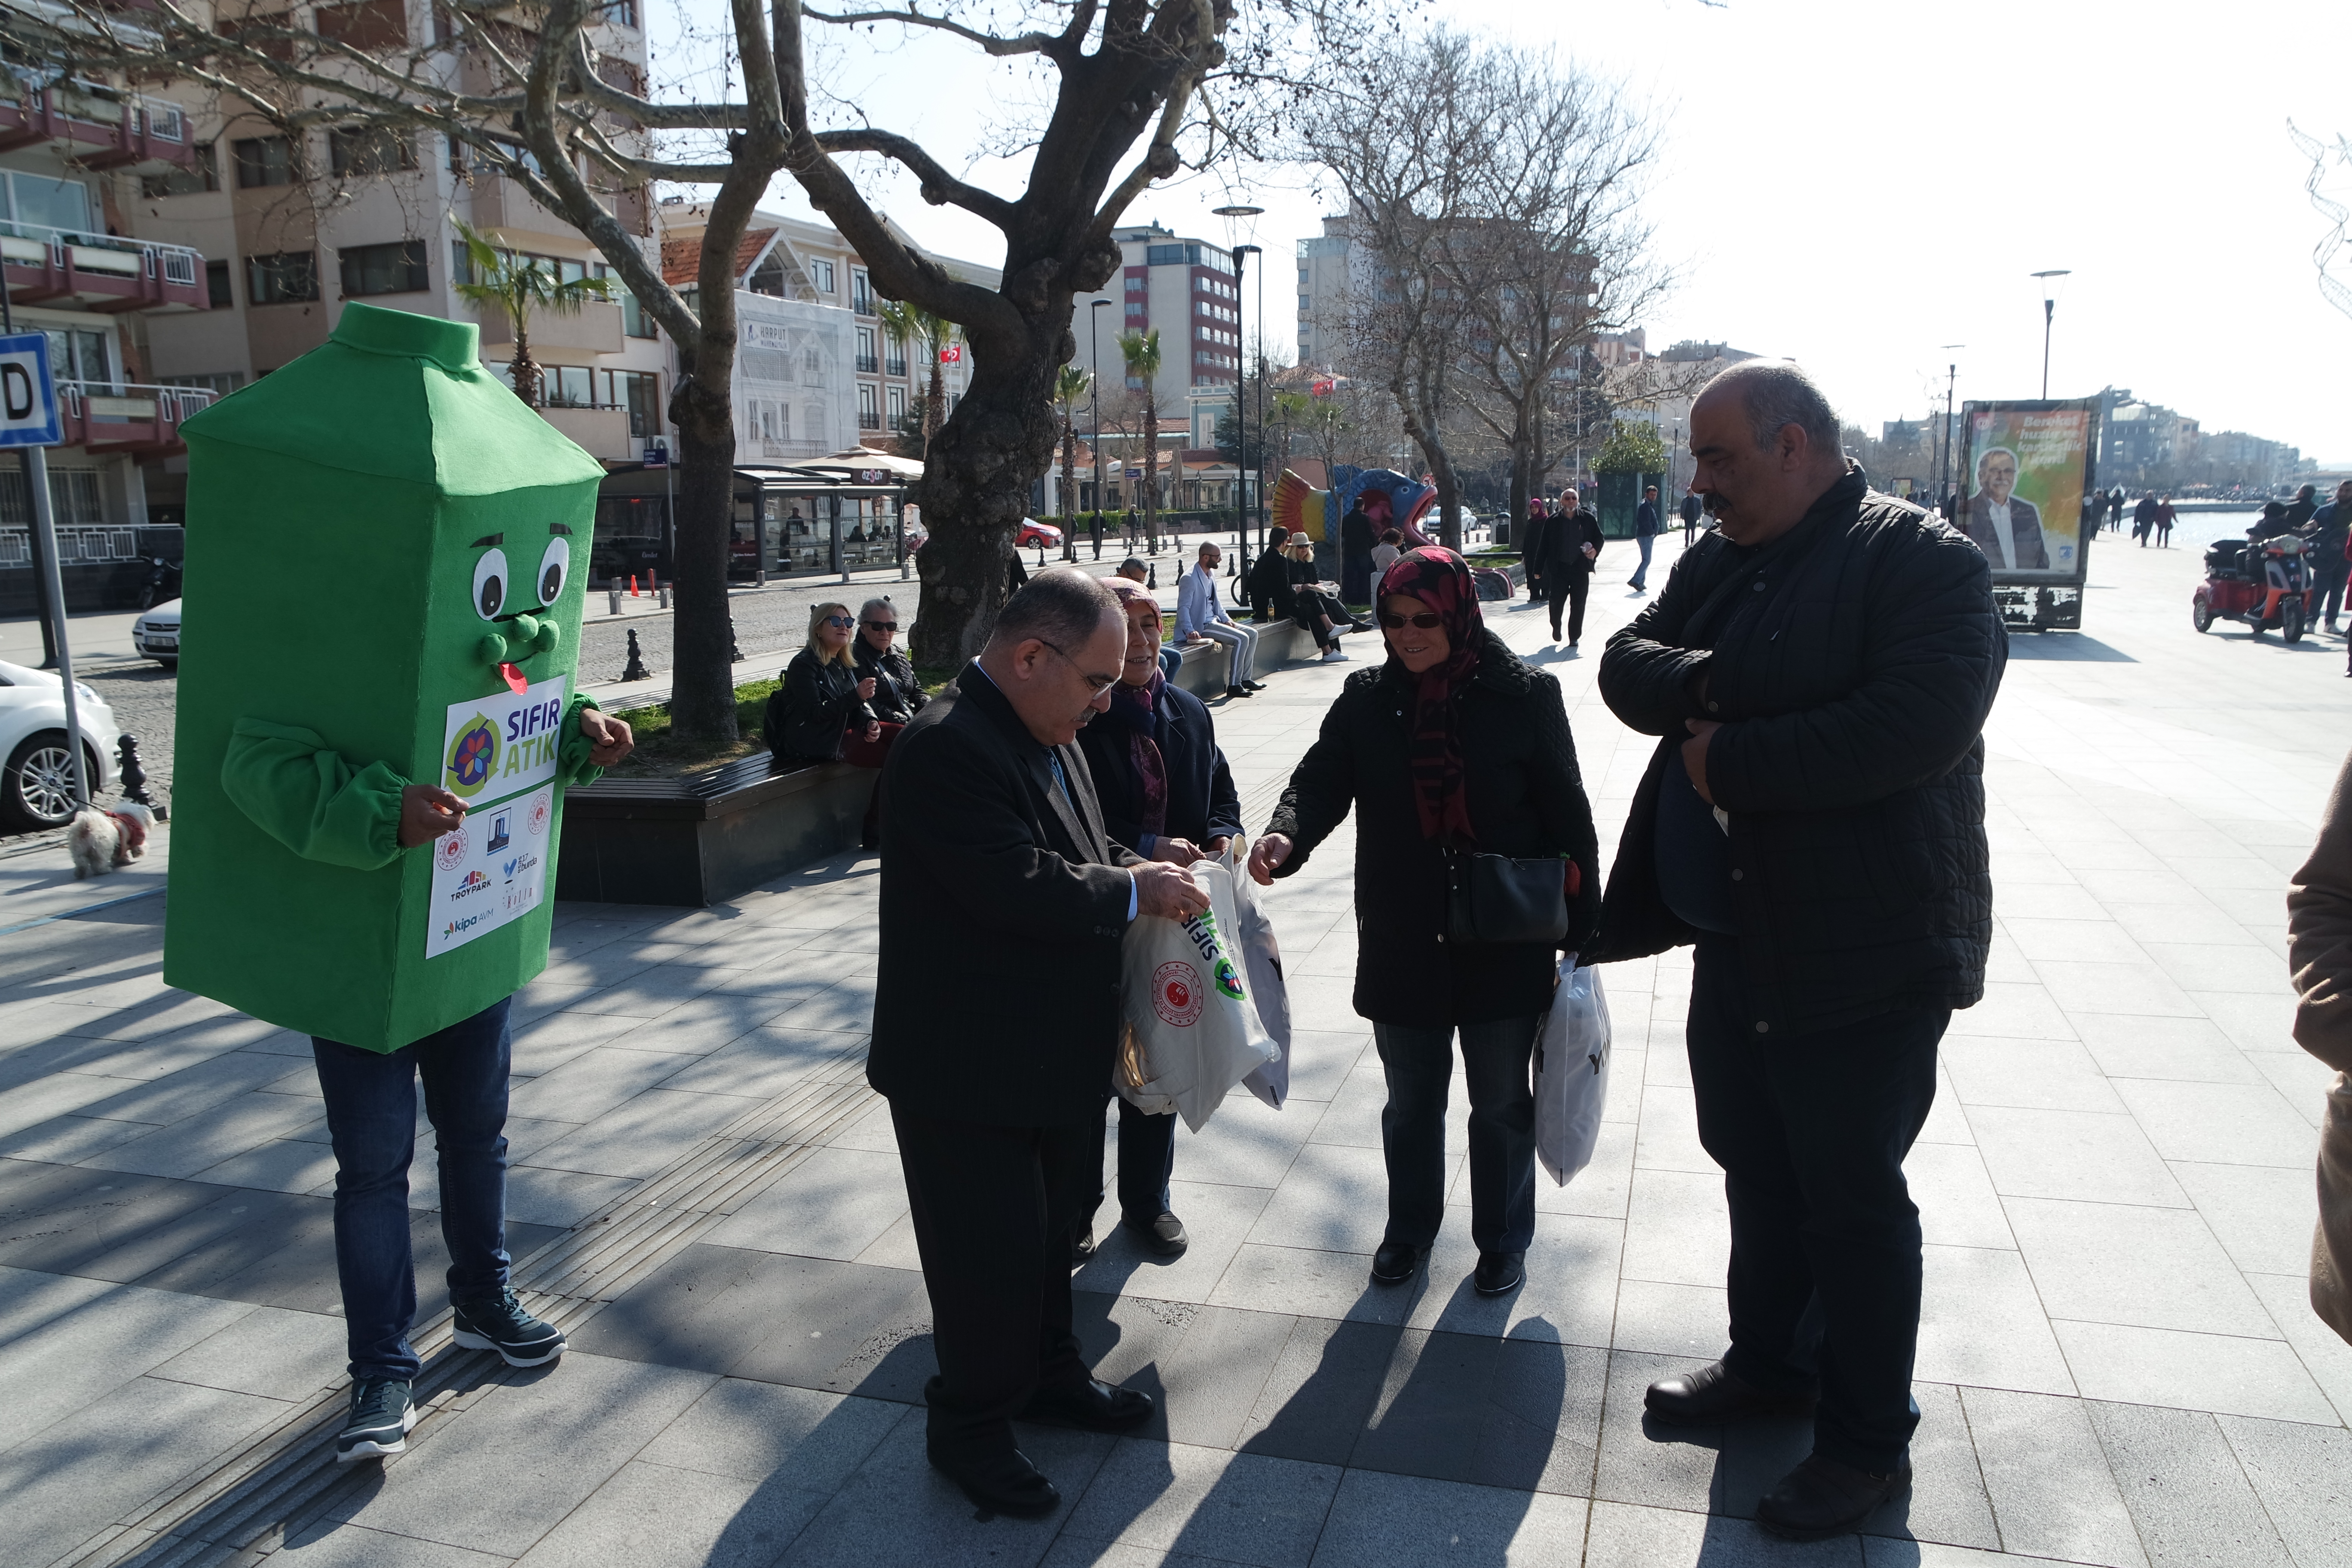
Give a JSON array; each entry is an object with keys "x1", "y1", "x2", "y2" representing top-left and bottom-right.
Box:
[{"x1": 0, "y1": 66, "x2": 211, "y2": 613}]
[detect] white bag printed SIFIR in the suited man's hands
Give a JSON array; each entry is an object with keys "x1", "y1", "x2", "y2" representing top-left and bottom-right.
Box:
[{"x1": 1112, "y1": 861, "x2": 1280, "y2": 1133}]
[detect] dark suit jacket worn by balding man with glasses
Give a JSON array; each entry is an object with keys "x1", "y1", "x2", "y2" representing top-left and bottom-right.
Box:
[{"x1": 866, "y1": 663, "x2": 1138, "y2": 1126}]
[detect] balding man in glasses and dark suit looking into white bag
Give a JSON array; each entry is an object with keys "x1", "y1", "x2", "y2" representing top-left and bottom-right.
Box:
[{"x1": 866, "y1": 567, "x2": 1207, "y2": 1516}]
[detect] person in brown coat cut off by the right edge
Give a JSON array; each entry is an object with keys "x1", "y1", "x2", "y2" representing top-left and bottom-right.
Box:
[{"x1": 2286, "y1": 757, "x2": 2352, "y2": 1342}]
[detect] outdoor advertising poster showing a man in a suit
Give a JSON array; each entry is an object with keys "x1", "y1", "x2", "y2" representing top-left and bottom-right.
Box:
[{"x1": 1959, "y1": 400, "x2": 2096, "y2": 583}]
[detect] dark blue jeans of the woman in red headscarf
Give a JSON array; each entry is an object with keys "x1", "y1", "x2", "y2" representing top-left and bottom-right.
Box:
[{"x1": 1371, "y1": 1016, "x2": 1543, "y2": 1253}]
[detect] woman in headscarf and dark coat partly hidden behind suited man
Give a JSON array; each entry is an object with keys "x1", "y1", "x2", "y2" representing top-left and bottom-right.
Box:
[{"x1": 1072, "y1": 576, "x2": 1242, "y2": 1258}]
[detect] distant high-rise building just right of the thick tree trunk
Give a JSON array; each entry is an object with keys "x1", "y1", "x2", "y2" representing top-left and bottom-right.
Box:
[{"x1": 1070, "y1": 224, "x2": 1265, "y2": 447}]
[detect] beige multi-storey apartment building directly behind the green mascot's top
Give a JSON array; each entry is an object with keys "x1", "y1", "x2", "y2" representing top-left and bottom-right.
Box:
[{"x1": 122, "y1": 0, "x2": 668, "y2": 533}]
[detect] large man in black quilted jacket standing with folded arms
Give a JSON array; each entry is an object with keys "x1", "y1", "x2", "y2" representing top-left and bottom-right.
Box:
[{"x1": 1588, "y1": 360, "x2": 2006, "y2": 1540}]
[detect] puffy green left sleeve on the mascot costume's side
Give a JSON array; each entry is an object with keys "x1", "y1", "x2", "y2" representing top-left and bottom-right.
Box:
[{"x1": 221, "y1": 720, "x2": 409, "y2": 872}]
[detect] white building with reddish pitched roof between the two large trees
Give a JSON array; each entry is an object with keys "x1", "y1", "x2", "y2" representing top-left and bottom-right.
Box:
[{"x1": 658, "y1": 200, "x2": 1002, "y2": 461}]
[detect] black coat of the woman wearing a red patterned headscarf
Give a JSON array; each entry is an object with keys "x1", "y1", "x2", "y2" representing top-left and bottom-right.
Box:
[{"x1": 1265, "y1": 632, "x2": 1599, "y2": 1025}]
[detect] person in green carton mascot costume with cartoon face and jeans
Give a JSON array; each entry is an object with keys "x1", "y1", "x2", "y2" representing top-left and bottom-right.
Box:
[{"x1": 165, "y1": 303, "x2": 628, "y2": 1460}]
